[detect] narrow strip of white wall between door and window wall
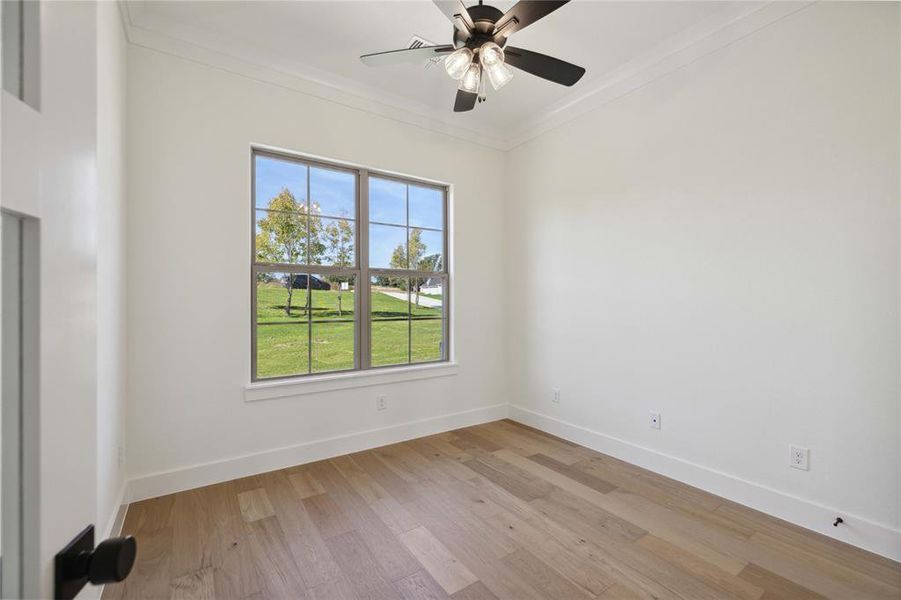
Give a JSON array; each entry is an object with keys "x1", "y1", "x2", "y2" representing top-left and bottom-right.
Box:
[{"x1": 97, "y1": 2, "x2": 127, "y2": 535}]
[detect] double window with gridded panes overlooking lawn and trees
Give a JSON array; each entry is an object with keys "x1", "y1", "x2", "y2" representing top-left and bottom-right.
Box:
[{"x1": 251, "y1": 150, "x2": 449, "y2": 381}]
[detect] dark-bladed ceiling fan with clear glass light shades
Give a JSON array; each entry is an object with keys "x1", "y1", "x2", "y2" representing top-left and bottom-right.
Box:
[{"x1": 360, "y1": 0, "x2": 585, "y2": 112}]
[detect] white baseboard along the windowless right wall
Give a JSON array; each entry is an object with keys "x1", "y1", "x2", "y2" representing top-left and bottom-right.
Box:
[{"x1": 509, "y1": 405, "x2": 901, "y2": 561}]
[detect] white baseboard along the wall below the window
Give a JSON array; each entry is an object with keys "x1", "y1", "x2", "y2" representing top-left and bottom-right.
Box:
[{"x1": 126, "y1": 404, "x2": 507, "y2": 502}]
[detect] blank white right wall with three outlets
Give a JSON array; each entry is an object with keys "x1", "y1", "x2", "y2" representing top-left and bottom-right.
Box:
[{"x1": 507, "y1": 3, "x2": 901, "y2": 555}]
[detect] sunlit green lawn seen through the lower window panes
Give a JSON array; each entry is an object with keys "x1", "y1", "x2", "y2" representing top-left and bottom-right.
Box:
[{"x1": 257, "y1": 283, "x2": 442, "y2": 378}]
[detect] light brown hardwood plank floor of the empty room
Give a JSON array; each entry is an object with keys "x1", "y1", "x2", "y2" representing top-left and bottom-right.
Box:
[{"x1": 104, "y1": 421, "x2": 901, "y2": 600}]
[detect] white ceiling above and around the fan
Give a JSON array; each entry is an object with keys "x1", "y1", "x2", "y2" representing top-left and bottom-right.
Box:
[{"x1": 126, "y1": 0, "x2": 761, "y2": 146}]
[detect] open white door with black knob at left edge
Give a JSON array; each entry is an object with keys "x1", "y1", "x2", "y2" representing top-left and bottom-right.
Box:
[{"x1": 0, "y1": 0, "x2": 107, "y2": 598}]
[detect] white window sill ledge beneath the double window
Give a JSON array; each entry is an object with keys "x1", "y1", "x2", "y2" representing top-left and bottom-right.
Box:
[{"x1": 244, "y1": 362, "x2": 460, "y2": 402}]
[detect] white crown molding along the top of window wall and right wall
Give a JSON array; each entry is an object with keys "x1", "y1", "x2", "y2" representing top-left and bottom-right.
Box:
[{"x1": 119, "y1": 0, "x2": 815, "y2": 151}]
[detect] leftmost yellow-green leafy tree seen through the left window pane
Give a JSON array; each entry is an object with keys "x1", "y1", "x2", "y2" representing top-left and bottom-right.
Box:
[{"x1": 256, "y1": 188, "x2": 325, "y2": 317}]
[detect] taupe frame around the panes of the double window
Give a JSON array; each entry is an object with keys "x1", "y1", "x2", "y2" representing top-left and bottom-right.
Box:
[{"x1": 245, "y1": 145, "x2": 456, "y2": 384}]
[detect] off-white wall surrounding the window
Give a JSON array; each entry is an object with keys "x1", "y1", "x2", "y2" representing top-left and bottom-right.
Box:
[{"x1": 127, "y1": 46, "x2": 509, "y2": 492}]
